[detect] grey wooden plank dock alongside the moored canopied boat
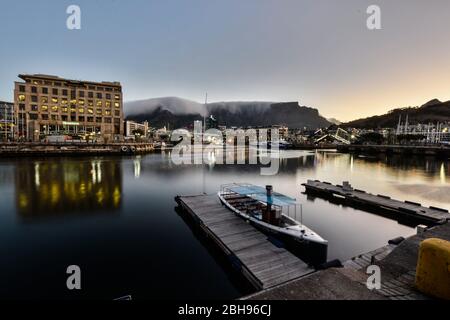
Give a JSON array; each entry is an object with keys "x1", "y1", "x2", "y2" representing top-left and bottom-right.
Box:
[{"x1": 175, "y1": 195, "x2": 314, "y2": 290}]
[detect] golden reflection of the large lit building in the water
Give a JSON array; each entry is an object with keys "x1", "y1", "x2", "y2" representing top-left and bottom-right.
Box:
[{"x1": 14, "y1": 159, "x2": 122, "y2": 220}]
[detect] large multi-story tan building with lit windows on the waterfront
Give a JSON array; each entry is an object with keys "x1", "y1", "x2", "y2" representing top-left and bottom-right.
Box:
[{"x1": 14, "y1": 74, "x2": 123, "y2": 142}]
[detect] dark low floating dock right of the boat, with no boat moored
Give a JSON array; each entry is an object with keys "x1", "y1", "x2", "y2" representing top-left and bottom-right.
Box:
[{"x1": 302, "y1": 180, "x2": 450, "y2": 225}]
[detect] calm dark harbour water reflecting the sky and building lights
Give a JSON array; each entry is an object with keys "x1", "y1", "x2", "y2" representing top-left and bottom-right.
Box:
[{"x1": 0, "y1": 151, "x2": 450, "y2": 299}]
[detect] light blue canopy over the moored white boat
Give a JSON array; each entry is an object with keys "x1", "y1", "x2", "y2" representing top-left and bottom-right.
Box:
[{"x1": 223, "y1": 184, "x2": 297, "y2": 207}]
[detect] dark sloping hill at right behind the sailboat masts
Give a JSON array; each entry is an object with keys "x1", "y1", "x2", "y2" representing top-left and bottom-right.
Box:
[{"x1": 342, "y1": 99, "x2": 450, "y2": 129}]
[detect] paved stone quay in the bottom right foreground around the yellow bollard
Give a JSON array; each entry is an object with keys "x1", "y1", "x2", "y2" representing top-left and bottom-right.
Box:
[{"x1": 242, "y1": 223, "x2": 450, "y2": 300}]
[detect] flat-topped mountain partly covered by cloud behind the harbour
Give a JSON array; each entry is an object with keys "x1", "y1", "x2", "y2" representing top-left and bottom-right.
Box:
[{"x1": 125, "y1": 97, "x2": 331, "y2": 129}]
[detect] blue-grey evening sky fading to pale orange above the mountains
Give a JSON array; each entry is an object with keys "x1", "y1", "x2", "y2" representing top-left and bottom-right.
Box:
[{"x1": 0, "y1": 0, "x2": 450, "y2": 121}]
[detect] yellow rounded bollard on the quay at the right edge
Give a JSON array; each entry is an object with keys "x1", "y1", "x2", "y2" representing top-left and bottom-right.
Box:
[{"x1": 416, "y1": 238, "x2": 450, "y2": 300}]
